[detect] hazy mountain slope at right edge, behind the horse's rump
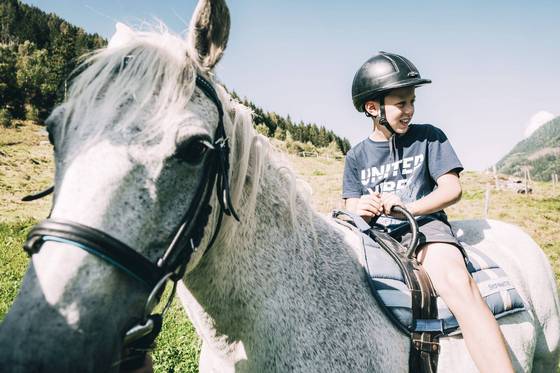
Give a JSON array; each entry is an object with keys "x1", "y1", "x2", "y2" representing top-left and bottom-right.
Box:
[{"x1": 496, "y1": 117, "x2": 560, "y2": 181}]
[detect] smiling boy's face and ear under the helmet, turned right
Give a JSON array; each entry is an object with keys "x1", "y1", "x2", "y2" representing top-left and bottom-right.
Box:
[{"x1": 365, "y1": 87, "x2": 416, "y2": 134}]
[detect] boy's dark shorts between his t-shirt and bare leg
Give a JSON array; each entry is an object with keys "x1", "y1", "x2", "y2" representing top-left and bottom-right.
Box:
[{"x1": 388, "y1": 216, "x2": 467, "y2": 259}]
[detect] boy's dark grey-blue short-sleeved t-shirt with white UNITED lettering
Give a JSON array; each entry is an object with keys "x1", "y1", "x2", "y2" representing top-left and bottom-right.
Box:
[{"x1": 342, "y1": 124, "x2": 463, "y2": 221}]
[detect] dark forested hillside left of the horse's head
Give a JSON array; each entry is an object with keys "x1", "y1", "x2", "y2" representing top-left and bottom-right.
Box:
[{"x1": 0, "y1": 0, "x2": 106, "y2": 119}]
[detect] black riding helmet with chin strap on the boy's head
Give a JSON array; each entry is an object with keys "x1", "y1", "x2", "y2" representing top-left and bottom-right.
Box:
[{"x1": 352, "y1": 52, "x2": 432, "y2": 133}]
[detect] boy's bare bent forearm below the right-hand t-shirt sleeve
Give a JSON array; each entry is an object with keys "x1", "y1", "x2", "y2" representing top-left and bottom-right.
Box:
[{"x1": 405, "y1": 172, "x2": 462, "y2": 215}]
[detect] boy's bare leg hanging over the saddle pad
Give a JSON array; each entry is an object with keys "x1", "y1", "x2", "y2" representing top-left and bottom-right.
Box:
[{"x1": 418, "y1": 243, "x2": 513, "y2": 373}]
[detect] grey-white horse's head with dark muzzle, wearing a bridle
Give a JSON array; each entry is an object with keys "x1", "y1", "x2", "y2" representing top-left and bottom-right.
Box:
[{"x1": 0, "y1": 0, "x2": 242, "y2": 372}]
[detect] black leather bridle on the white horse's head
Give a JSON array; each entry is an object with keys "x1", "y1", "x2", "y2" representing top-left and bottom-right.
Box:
[{"x1": 23, "y1": 75, "x2": 239, "y2": 360}]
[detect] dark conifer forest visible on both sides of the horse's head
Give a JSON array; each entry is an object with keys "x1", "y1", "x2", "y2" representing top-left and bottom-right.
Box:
[{"x1": 0, "y1": 0, "x2": 350, "y2": 156}]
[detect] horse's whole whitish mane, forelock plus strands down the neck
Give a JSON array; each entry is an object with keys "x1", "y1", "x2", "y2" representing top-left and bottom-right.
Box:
[{"x1": 47, "y1": 23, "x2": 316, "y2": 242}]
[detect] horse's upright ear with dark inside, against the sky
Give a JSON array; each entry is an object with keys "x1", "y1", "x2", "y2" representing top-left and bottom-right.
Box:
[{"x1": 188, "y1": 0, "x2": 230, "y2": 70}]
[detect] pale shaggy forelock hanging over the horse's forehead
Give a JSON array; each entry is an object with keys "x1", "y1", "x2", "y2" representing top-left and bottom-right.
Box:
[{"x1": 49, "y1": 25, "x2": 196, "y2": 150}]
